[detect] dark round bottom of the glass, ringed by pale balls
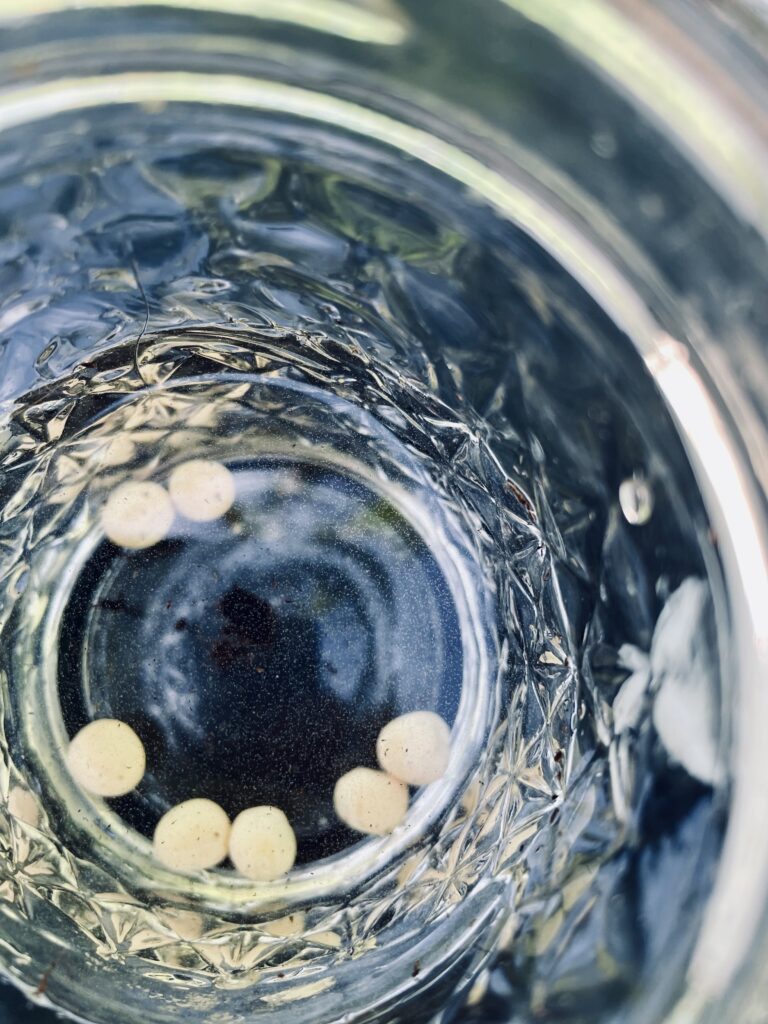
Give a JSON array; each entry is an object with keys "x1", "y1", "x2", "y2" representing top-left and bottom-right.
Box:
[{"x1": 59, "y1": 460, "x2": 462, "y2": 862}]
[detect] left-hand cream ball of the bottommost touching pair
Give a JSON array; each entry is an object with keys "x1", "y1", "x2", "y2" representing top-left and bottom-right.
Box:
[{"x1": 153, "y1": 798, "x2": 231, "y2": 871}]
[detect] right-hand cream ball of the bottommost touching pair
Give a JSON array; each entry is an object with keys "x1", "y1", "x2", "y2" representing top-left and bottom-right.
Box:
[{"x1": 229, "y1": 806, "x2": 296, "y2": 882}]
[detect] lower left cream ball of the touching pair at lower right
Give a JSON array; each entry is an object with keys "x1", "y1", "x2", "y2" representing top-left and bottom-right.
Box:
[{"x1": 334, "y1": 768, "x2": 408, "y2": 836}]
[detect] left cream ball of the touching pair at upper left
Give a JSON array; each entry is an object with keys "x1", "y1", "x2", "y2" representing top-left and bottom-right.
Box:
[{"x1": 101, "y1": 480, "x2": 173, "y2": 549}]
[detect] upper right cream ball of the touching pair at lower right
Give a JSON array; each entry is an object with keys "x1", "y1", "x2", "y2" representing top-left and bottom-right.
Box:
[{"x1": 376, "y1": 711, "x2": 451, "y2": 785}]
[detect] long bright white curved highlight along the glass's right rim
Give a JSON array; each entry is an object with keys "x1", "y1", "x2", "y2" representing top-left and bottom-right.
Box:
[{"x1": 646, "y1": 335, "x2": 768, "y2": 1000}]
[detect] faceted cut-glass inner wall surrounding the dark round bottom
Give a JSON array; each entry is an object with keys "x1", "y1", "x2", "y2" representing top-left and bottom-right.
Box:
[{"x1": 0, "y1": 70, "x2": 722, "y2": 1024}]
